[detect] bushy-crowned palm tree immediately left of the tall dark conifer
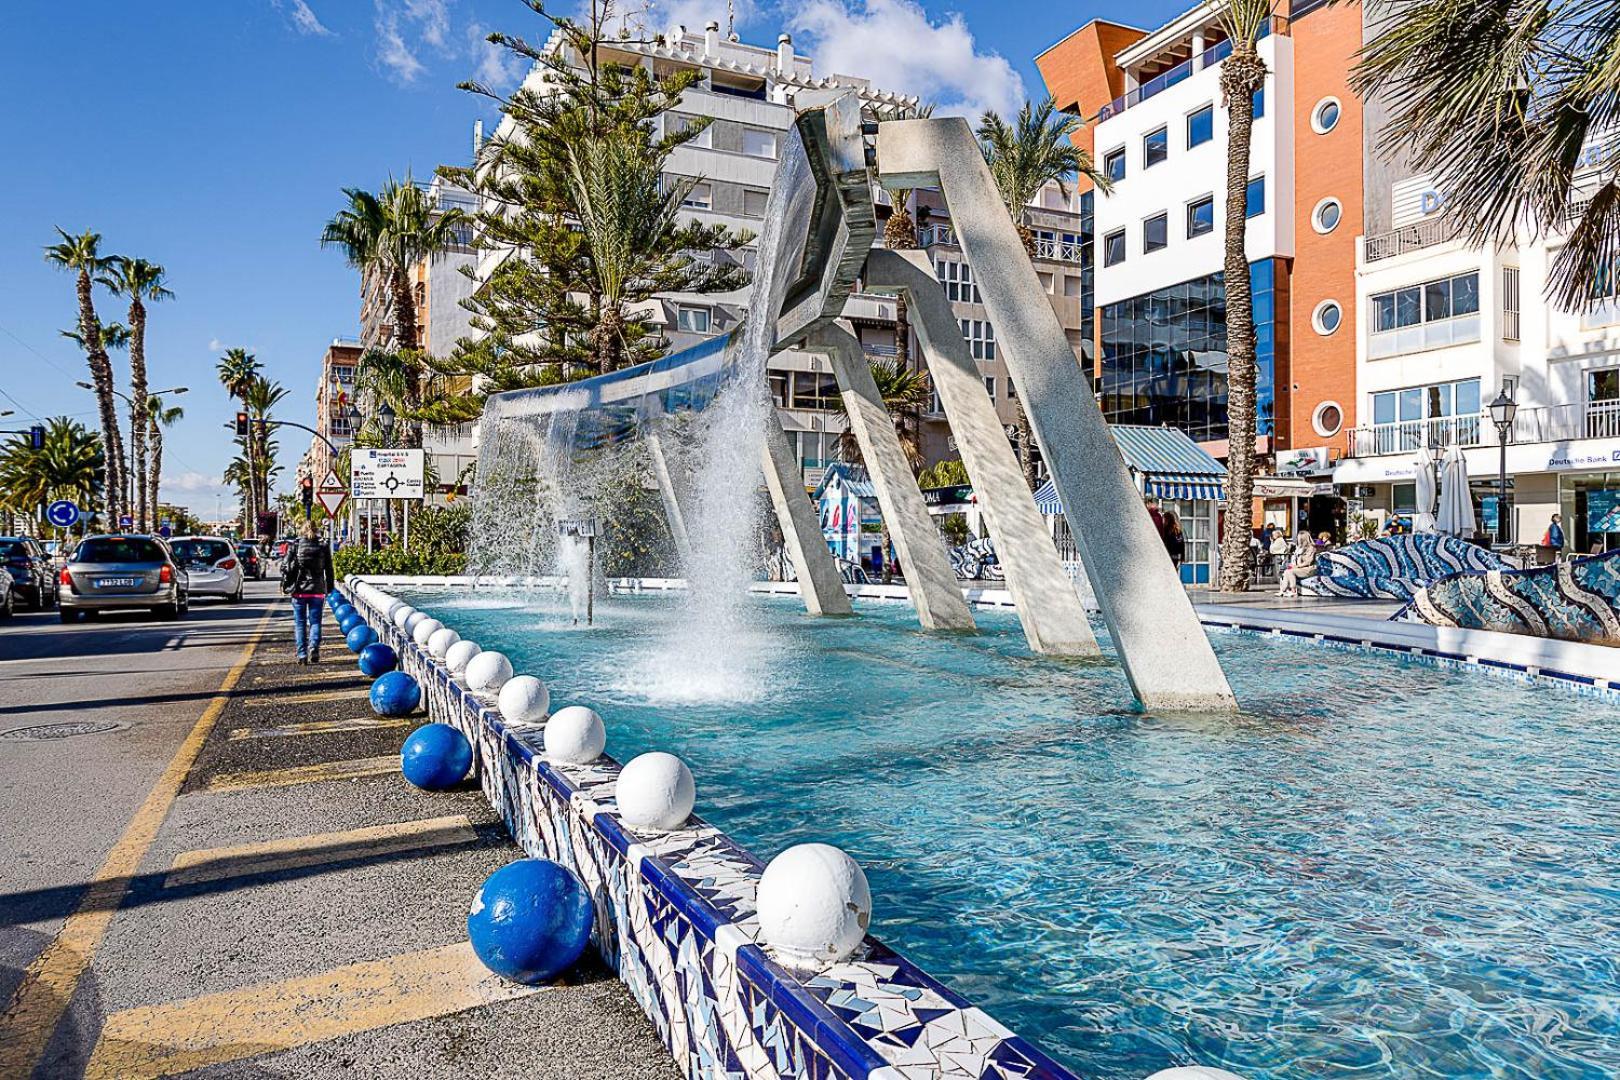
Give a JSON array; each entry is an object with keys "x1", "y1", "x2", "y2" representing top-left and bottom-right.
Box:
[{"x1": 321, "y1": 173, "x2": 470, "y2": 350}]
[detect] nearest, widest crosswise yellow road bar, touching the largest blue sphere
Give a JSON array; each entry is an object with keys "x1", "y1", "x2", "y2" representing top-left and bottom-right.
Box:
[{"x1": 84, "y1": 941, "x2": 541, "y2": 1080}]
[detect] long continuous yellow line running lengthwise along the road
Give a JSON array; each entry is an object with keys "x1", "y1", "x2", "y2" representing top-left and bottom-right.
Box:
[{"x1": 0, "y1": 609, "x2": 274, "y2": 1077}]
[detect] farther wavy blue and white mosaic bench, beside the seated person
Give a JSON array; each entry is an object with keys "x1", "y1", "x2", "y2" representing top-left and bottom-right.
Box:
[{"x1": 1299, "y1": 533, "x2": 1513, "y2": 601}]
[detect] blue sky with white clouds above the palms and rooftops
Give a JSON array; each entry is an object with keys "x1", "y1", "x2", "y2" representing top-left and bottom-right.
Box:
[{"x1": 0, "y1": 0, "x2": 1189, "y2": 518}]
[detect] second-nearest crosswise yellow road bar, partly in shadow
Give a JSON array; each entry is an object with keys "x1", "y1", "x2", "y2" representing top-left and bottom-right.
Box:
[{"x1": 164, "y1": 814, "x2": 478, "y2": 889}]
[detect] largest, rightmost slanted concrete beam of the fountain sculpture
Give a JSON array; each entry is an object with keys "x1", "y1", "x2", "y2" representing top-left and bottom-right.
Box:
[{"x1": 878, "y1": 117, "x2": 1238, "y2": 711}]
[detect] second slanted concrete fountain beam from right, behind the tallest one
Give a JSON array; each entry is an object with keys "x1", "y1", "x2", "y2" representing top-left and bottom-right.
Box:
[{"x1": 865, "y1": 251, "x2": 1100, "y2": 656}]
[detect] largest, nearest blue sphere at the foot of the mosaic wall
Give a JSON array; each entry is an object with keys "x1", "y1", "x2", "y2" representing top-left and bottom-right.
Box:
[{"x1": 467, "y1": 858, "x2": 595, "y2": 986}]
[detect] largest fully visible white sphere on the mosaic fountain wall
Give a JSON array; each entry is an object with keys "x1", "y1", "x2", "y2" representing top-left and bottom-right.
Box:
[{"x1": 758, "y1": 844, "x2": 872, "y2": 967}]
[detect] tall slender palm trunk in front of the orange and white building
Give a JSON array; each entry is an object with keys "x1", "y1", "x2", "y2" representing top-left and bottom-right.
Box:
[{"x1": 1218, "y1": 0, "x2": 1275, "y2": 593}]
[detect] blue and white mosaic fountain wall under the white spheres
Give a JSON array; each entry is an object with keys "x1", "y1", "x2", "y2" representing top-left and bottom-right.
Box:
[{"x1": 343, "y1": 588, "x2": 1074, "y2": 1080}]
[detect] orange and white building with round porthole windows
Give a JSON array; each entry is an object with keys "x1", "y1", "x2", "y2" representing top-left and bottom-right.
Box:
[{"x1": 1035, "y1": 0, "x2": 1371, "y2": 528}]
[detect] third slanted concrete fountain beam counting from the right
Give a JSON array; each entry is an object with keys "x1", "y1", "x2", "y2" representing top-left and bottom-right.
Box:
[{"x1": 805, "y1": 325, "x2": 974, "y2": 630}]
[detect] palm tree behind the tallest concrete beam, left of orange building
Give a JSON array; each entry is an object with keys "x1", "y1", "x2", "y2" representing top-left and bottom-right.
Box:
[{"x1": 978, "y1": 97, "x2": 1111, "y2": 489}]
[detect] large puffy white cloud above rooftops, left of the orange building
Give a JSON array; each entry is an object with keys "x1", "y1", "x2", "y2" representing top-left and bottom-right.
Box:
[{"x1": 789, "y1": 0, "x2": 1024, "y2": 120}]
